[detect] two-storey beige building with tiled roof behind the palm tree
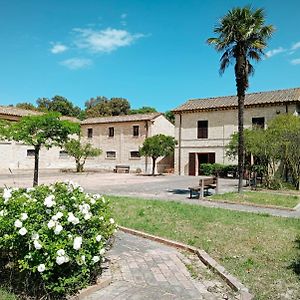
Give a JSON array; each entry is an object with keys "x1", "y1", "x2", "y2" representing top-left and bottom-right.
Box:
[{"x1": 173, "y1": 88, "x2": 300, "y2": 175}]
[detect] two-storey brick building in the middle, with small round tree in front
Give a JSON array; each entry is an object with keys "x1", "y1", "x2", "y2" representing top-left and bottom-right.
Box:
[{"x1": 81, "y1": 113, "x2": 174, "y2": 173}]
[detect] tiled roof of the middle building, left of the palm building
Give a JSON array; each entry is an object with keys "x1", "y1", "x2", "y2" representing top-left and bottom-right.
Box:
[{"x1": 81, "y1": 113, "x2": 162, "y2": 125}]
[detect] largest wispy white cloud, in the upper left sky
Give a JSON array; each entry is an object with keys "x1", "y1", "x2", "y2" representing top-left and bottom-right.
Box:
[{"x1": 74, "y1": 27, "x2": 145, "y2": 53}]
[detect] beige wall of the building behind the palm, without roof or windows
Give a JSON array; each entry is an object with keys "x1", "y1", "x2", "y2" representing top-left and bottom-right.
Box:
[{"x1": 174, "y1": 105, "x2": 297, "y2": 175}]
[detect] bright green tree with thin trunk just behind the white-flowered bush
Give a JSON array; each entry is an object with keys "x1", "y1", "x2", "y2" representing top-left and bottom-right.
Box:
[{"x1": 0, "y1": 113, "x2": 80, "y2": 186}]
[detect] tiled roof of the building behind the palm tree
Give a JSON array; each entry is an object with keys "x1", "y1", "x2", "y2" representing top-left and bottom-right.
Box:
[{"x1": 173, "y1": 88, "x2": 300, "y2": 113}]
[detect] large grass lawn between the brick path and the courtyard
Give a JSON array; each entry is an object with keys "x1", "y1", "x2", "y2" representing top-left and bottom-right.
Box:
[{"x1": 107, "y1": 196, "x2": 300, "y2": 299}]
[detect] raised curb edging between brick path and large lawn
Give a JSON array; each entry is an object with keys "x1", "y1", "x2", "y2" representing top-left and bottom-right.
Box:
[{"x1": 118, "y1": 226, "x2": 253, "y2": 300}]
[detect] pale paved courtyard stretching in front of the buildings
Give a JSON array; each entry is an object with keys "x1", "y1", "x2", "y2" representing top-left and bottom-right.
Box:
[{"x1": 0, "y1": 170, "x2": 300, "y2": 218}]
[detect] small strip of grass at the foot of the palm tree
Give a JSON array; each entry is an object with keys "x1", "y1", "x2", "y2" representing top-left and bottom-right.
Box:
[{"x1": 208, "y1": 191, "x2": 300, "y2": 208}]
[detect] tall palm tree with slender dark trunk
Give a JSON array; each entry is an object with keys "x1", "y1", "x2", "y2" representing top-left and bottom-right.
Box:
[{"x1": 207, "y1": 6, "x2": 274, "y2": 193}]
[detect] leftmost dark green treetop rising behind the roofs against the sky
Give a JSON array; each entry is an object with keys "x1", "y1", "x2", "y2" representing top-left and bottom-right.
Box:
[{"x1": 36, "y1": 96, "x2": 81, "y2": 117}]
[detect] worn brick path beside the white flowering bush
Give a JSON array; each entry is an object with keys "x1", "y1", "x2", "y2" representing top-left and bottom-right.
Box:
[{"x1": 85, "y1": 232, "x2": 238, "y2": 300}]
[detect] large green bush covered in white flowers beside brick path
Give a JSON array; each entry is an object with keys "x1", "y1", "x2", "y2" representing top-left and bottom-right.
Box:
[{"x1": 0, "y1": 182, "x2": 116, "y2": 299}]
